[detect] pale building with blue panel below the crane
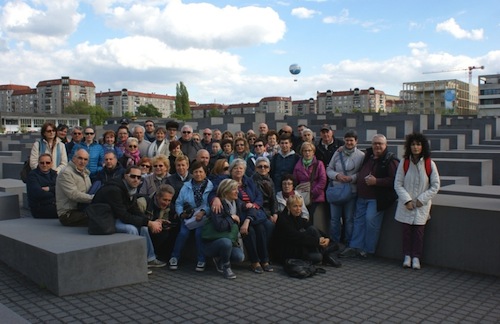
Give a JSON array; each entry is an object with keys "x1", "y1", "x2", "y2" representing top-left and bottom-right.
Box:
[{"x1": 400, "y1": 79, "x2": 478, "y2": 114}]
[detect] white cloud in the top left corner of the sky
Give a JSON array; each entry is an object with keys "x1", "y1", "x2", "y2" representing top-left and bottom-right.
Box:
[{"x1": 0, "y1": 0, "x2": 84, "y2": 49}]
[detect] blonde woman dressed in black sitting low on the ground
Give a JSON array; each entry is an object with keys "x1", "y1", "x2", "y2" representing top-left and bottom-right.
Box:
[{"x1": 276, "y1": 195, "x2": 342, "y2": 267}]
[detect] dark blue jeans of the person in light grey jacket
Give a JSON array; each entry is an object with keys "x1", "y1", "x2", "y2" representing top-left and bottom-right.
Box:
[{"x1": 330, "y1": 196, "x2": 356, "y2": 245}]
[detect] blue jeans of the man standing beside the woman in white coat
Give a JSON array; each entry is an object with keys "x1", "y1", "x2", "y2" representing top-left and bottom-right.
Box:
[{"x1": 349, "y1": 197, "x2": 384, "y2": 253}]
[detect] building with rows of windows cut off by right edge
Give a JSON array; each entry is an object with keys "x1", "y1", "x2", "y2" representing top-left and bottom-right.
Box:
[{"x1": 478, "y1": 74, "x2": 500, "y2": 116}]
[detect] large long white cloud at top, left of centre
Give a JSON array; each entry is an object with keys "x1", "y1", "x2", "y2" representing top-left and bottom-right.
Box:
[{"x1": 101, "y1": 0, "x2": 286, "y2": 49}]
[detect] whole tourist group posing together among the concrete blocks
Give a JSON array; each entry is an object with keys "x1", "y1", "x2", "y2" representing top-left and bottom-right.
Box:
[{"x1": 27, "y1": 119, "x2": 439, "y2": 279}]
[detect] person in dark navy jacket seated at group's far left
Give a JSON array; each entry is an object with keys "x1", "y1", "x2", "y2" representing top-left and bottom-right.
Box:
[{"x1": 26, "y1": 153, "x2": 57, "y2": 218}]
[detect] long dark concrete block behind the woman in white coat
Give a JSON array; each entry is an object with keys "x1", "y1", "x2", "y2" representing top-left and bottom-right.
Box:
[{"x1": 376, "y1": 194, "x2": 500, "y2": 276}]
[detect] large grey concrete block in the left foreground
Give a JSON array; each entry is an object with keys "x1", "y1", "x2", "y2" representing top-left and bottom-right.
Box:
[{"x1": 0, "y1": 218, "x2": 148, "y2": 296}]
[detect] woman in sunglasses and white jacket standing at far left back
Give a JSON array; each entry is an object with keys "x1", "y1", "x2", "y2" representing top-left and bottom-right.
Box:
[{"x1": 29, "y1": 122, "x2": 68, "y2": 172}]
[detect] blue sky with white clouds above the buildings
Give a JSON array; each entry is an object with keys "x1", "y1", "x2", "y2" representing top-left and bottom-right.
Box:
[{"x1": 0, "y1": 0, "x2": 500, "y2": 104}]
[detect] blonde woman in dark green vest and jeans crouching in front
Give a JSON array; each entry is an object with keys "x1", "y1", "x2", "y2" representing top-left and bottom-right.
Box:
[{"x1": 204, "y1": 179, "x2": 245, "y2": 279}]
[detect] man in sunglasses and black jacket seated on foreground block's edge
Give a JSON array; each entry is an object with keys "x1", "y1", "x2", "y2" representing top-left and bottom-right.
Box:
[{"x1": 92, "y1": 165, "x2": 166, "y2": 273}]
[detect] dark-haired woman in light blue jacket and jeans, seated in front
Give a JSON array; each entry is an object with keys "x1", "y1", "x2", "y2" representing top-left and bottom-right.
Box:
[{"x1": 167, "y1": 159, "x2": 213, "y2": 271}]
